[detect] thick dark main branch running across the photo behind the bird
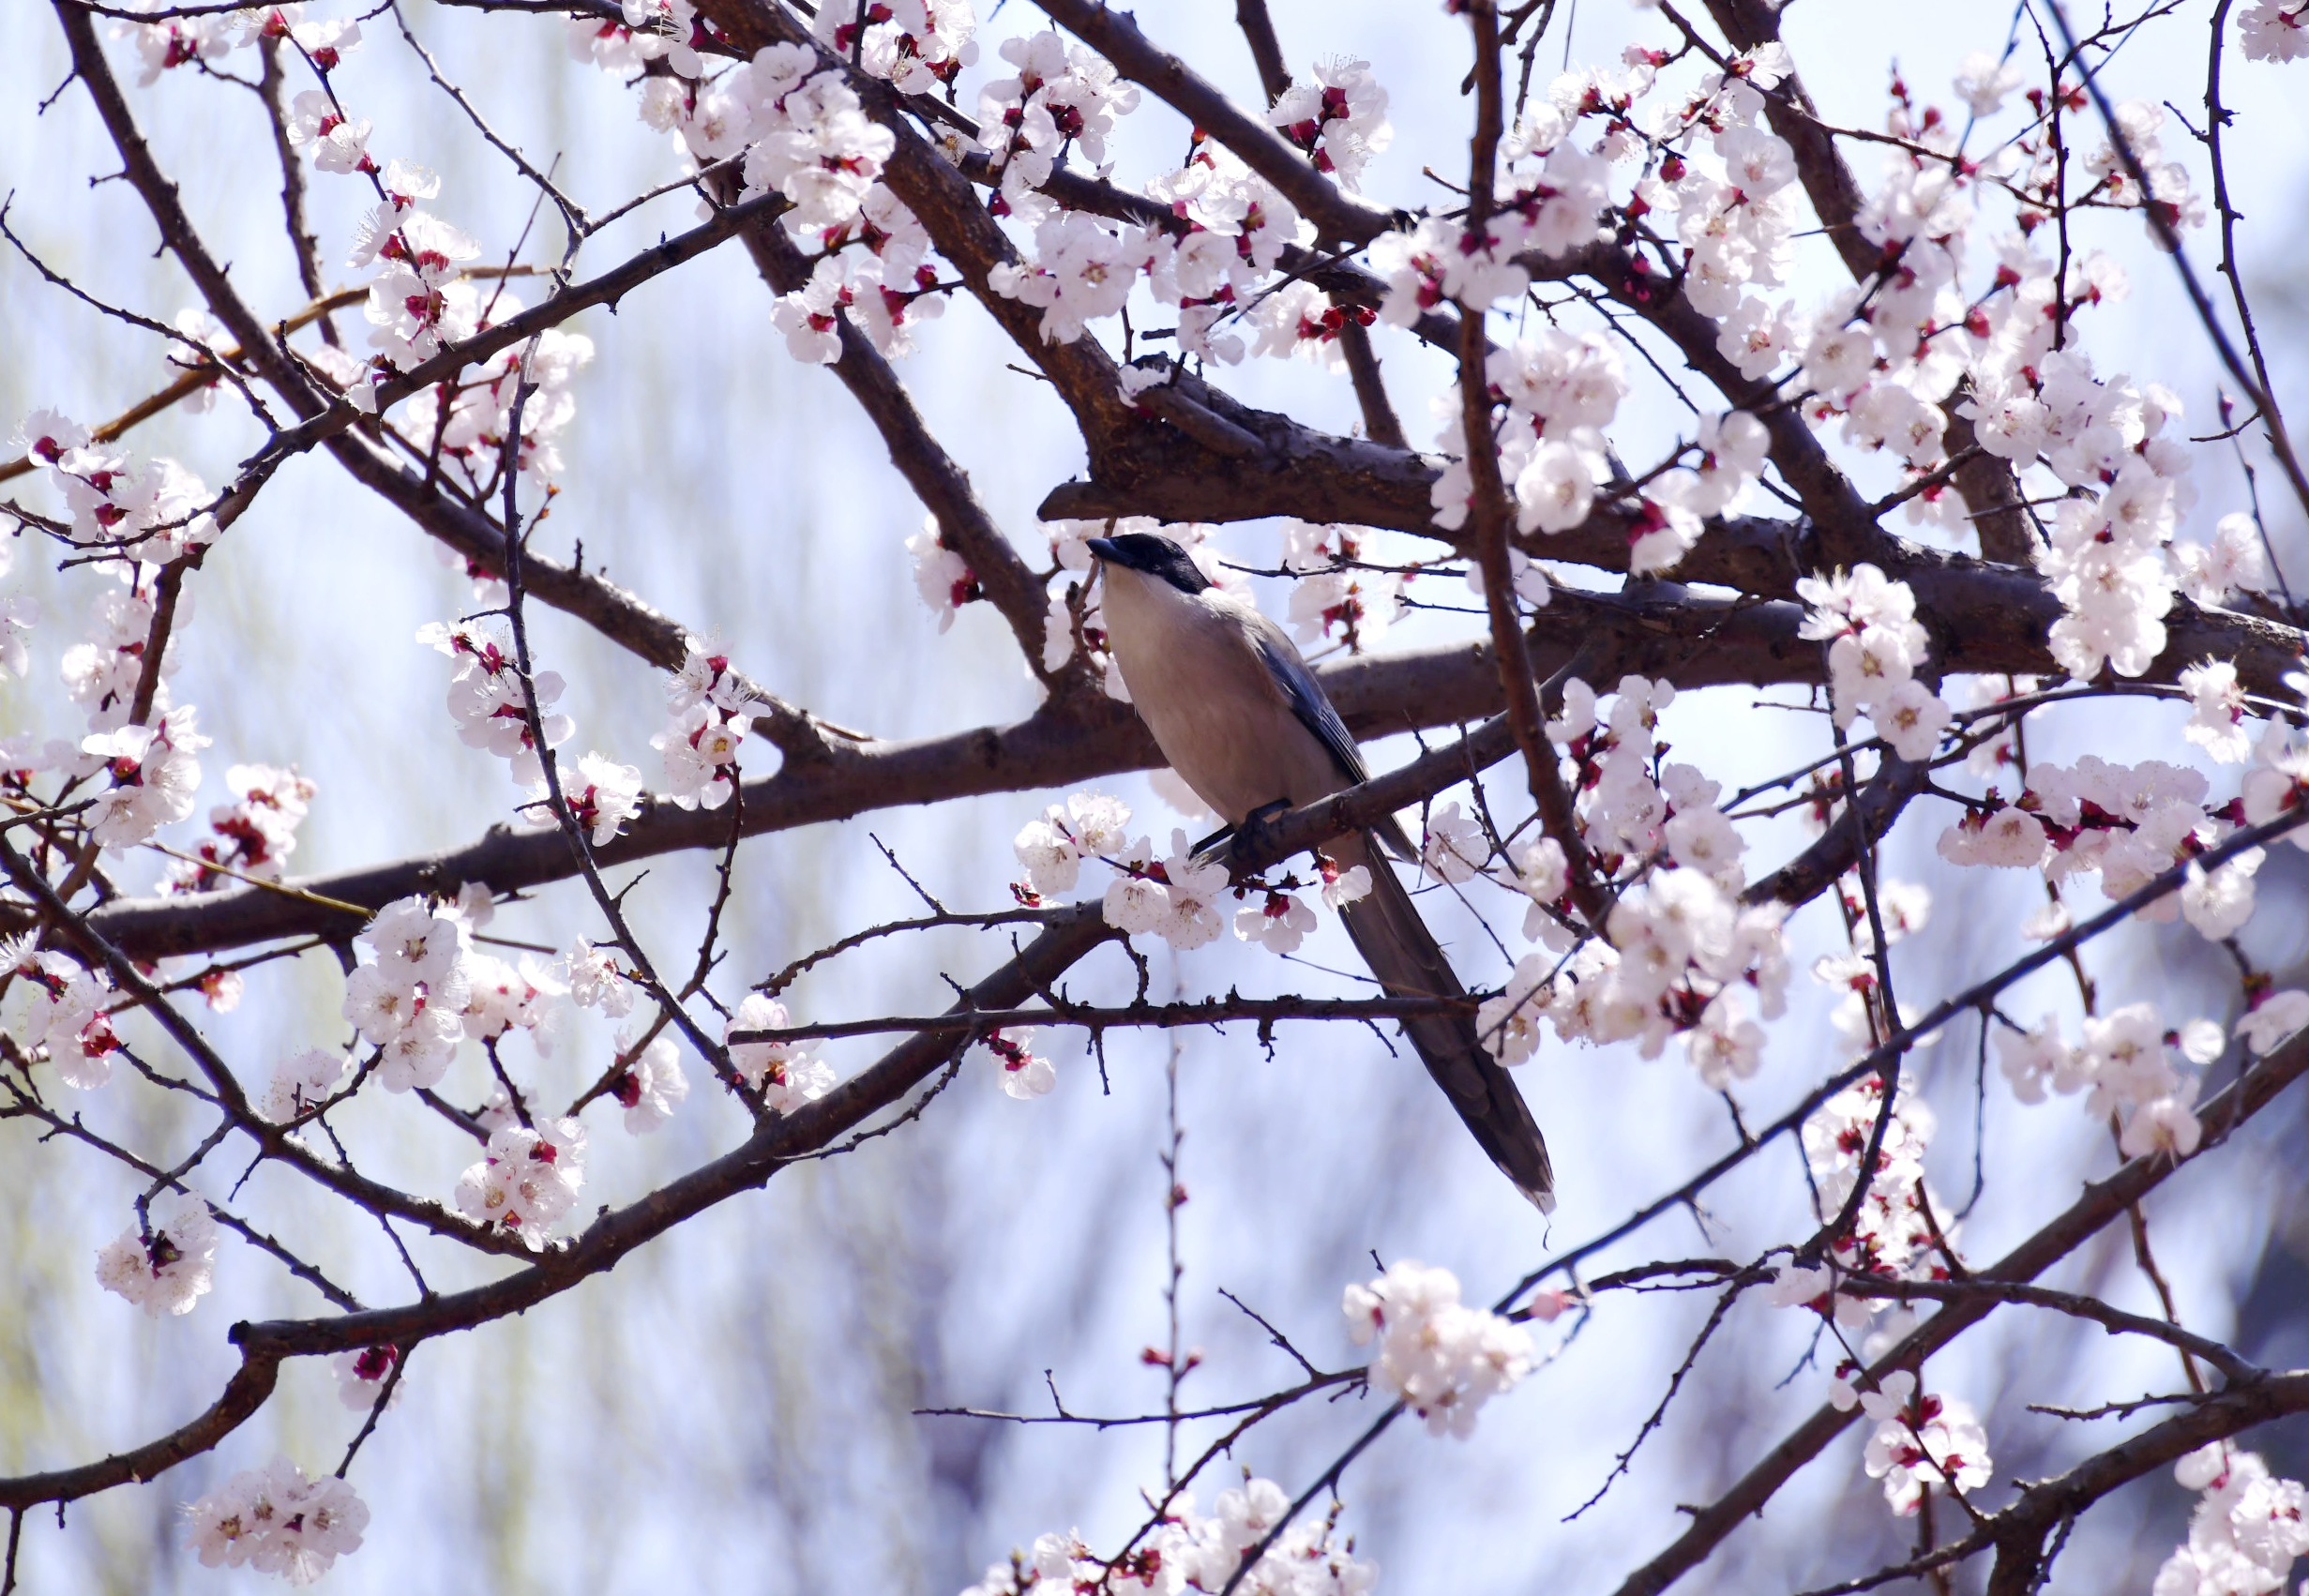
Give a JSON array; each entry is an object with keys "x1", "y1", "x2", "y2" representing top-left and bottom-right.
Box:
[{"x1": 23, "y1": 570, "x2": 2298, "y2": 958}]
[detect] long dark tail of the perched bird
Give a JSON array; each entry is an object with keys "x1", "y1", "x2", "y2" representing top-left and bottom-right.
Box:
[{"x1": 1325, "y1": 836, "x2": 1556, "y2": 1212}]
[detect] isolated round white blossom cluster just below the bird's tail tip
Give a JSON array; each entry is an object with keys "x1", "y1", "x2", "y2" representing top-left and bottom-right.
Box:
[{"x1": 1339, "y1": 1258, "x2": 1531, "y2": 1439}]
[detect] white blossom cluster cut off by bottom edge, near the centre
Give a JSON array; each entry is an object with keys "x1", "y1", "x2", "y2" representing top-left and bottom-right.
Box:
[{"x1": 963, "y1": 1471, "x2": 1379, "y2": 1596}]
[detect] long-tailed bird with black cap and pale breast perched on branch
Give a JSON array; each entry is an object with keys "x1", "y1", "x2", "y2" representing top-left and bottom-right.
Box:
[{"x1": 1090, "y1": 532, "x2": 1556, "y2": 1212}]
